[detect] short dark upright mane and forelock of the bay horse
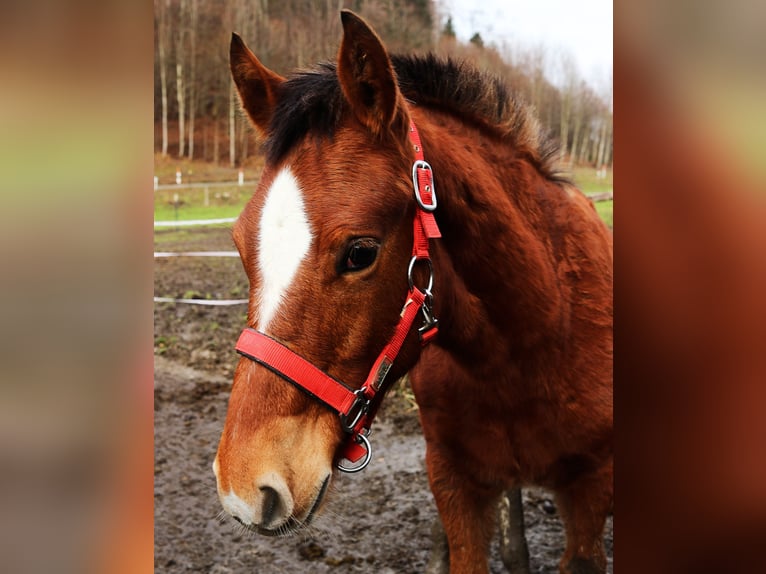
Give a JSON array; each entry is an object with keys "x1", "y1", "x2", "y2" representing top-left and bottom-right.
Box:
[{"x1": 264, "y1": 54, "x2": 566, "y2": 181}]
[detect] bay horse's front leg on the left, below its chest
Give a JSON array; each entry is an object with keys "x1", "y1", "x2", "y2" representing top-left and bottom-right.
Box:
[{"x1": 426, "y1": 445, "x2": 499, "y2": 574}]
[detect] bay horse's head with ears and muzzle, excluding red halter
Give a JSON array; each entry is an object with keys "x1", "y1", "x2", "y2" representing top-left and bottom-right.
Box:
[{"x1": 213, "y1": 11, "x2": 427, "y2": 534}]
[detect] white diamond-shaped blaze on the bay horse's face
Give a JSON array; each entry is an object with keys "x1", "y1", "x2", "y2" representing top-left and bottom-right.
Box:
[{"x1": 258, "y1": 167, "x2": 312, "y2": 332}]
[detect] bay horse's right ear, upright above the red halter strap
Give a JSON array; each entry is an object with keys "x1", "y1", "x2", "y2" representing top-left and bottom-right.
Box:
[{"x1": 338, "y1": 10, "x2": 402, "y2": 135}]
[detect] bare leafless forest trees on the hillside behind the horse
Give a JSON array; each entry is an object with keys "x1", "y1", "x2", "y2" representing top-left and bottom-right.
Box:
[{"x1": 154, "y1": 0, "x2": 613, "y2": 171}]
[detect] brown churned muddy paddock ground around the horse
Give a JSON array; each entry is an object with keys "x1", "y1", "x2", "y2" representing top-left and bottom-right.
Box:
[{"x1": 154, "y1": 228, "x2": 612, "y2": 574}]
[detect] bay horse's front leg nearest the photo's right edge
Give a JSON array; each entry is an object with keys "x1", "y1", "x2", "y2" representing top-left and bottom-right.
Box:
[{"x1": 556, "y1": 461, "x2": 613, "y2": 574}]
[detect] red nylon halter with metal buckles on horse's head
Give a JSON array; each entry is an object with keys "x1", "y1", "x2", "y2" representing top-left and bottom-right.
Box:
[{"x1": 236, "y1": 121, "x2": 441, "y2": 472}]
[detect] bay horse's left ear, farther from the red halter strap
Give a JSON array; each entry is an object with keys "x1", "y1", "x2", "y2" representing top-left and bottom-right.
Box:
[{"x1": 229, "y1": 33, "x2": 285, "y2": 135}]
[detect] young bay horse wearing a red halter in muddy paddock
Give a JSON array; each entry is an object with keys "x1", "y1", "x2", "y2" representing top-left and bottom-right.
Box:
[{"x1": 213, "y1": 11, "x2": 613, "y2": 573}]
